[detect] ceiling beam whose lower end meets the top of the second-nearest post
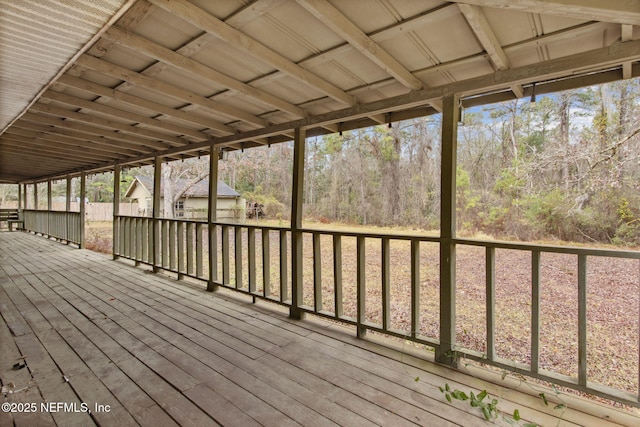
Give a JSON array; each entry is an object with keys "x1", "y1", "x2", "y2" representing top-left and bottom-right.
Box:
[{"x1": 104, "y1": 27, "x2": 306, "y2": 117}]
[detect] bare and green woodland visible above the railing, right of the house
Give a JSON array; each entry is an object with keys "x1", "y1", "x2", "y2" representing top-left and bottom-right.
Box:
[{"x1": 220, "y1": 79, "x2": 640, "y2": 245}]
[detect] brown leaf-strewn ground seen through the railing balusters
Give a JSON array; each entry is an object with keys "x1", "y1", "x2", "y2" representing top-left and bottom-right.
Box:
[{"x1": 86, "y1": 222, "x2": 640, "y2": 404}]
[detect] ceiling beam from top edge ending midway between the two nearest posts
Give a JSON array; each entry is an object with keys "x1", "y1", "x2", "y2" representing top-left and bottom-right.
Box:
[{"x1": 149, "y1": 0, "x2": 356, "y2": 105}]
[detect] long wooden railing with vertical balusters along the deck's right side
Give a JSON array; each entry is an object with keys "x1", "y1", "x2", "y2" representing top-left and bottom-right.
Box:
[{"x1": 114, "y1": 216, "x2": 640, "y2": 406}]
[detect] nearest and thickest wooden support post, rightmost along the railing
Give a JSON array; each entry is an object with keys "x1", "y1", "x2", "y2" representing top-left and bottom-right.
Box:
[{"x1": 436, "y1": 96, "x2": 459, "y2": 366}]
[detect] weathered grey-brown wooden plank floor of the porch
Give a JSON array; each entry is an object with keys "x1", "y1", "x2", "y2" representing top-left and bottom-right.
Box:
[{"x1": 0, "y1": 232, "x2": 640, "y2": 427}]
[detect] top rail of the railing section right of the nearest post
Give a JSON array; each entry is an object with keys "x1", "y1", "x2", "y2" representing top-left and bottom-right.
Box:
[{"x1": 453, "y1": 239, "x2": 640, "y2": 259}]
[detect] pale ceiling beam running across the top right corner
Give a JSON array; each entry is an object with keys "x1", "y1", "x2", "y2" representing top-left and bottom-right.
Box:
[{"x1": 454, "y1": 0, "x2": 640, "y2": 25}]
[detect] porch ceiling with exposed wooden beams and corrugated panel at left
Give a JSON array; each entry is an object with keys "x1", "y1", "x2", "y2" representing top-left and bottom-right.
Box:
[{"x1": 0, "y1": 0, "x2": 640, "y2": 183}]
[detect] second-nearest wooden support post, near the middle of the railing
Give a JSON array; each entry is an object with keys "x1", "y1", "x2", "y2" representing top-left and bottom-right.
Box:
[{"x1": 292, "y1": 128, "x2": 307, "y2": 320}]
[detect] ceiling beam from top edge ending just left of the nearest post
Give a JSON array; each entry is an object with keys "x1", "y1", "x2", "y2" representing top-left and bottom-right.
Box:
[{"x1": 296, "y1": 0, "x2": 424, "y2": 90}]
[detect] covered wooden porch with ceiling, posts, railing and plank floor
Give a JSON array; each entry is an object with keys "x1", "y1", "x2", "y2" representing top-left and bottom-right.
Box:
[{"x1": 0, "y1": 0, "x2": 640, "y2": 427}]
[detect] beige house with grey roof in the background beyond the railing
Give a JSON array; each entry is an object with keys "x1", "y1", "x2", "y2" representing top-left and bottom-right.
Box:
[{"x1": 125, "y1": 176, "x2": 245, "y2": 221}]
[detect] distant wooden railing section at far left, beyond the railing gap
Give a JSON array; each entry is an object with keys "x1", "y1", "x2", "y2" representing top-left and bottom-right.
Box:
[{"x1": 23, "y1": 209, "x2": 84, "y2": 245}]
